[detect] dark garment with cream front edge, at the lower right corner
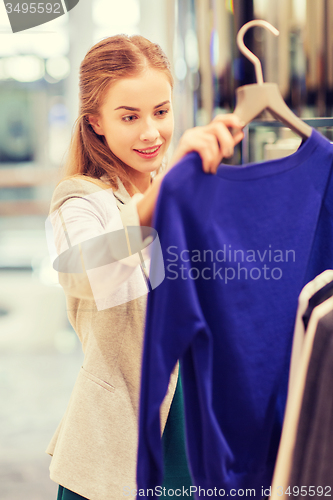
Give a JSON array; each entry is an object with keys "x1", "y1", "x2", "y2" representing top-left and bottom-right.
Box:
[{"x1": 271, "y1": 297, "x2": 333, "y2": 500}]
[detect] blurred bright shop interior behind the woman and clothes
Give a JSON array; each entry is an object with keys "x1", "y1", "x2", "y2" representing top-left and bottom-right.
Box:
[{"x1": 0, "y1": 0, "x2": 333, "y2": 500}]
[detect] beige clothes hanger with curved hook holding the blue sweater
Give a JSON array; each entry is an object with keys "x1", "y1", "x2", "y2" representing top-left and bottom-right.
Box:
[{"x1": 234, "y1": 20, "x2": 312, "y2": 139}]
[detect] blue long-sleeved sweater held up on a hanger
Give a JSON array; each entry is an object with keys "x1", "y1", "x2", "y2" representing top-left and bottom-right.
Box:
[{"x1": 137, "y1": 130, "x2": 333, "y2": 499}]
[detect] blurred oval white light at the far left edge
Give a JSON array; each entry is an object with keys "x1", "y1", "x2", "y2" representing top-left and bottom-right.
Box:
[{"x1": 3, "y1": 56, "x2": 45, "y2": 82}]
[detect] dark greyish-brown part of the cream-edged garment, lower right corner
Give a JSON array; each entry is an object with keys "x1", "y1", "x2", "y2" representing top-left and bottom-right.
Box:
[{"x1": 289, "y1": 306, "x2": 333, "y2": 498}]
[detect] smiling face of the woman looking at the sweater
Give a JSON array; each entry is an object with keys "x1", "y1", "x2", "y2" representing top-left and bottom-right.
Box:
[{"x1": 89, "y1": 69, "x2": 174, "y2": 173}]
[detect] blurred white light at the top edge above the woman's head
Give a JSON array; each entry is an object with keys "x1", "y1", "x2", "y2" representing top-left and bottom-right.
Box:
[{"x1": 93, "y1": 0, "x2": 140, "y2": 27}]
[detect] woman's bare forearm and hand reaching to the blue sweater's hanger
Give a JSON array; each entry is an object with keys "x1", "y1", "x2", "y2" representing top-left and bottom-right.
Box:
[{"x1": 137, "y1": 114, "x2": 244, "y2": 226}]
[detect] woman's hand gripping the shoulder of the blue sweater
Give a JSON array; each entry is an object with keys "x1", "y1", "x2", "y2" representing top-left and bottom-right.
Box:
[{"x1": 169, "y1": 114, "x2": 245, "y2": 174}]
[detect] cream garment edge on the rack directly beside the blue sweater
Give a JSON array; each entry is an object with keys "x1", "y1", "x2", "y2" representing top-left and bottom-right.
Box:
[{"x1": 272, "y1": 269, "x2": 333, "y2": 499}]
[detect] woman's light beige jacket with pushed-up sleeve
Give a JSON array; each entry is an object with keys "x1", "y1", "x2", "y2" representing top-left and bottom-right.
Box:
[{"x1": 46, "y1": 178, "x2": 178, "y2": 500}]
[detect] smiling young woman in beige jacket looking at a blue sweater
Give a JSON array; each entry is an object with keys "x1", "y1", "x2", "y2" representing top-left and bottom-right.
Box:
[{"x1": 47, "y1": 35, "x2": 243, "y2": 500}]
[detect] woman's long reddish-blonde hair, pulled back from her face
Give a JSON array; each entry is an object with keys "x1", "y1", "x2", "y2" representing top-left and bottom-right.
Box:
[{"x1": 64, "y1": 35, "x2": 173, "y2": 189}]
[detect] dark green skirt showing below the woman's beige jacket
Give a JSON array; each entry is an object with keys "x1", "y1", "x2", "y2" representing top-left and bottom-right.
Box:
[{"x1": 57, "y1": 372, "x2": 193, "y2": 500}]
